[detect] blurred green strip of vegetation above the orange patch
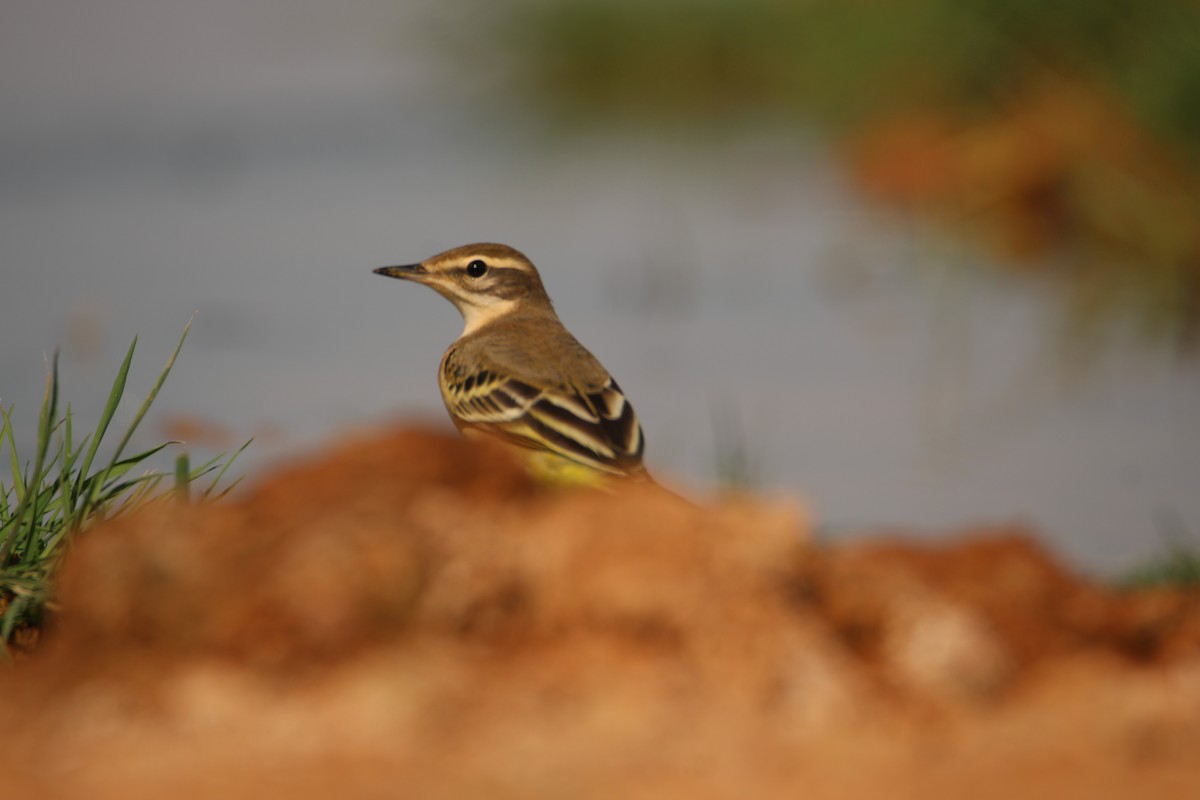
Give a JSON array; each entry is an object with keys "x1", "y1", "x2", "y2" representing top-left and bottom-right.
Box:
[{"x1": 500, "y1": 0, "x2": 1200, "y2": 143}]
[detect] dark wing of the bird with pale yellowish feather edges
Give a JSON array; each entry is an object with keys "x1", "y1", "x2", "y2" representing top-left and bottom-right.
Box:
[{"x1": 443, "y1": 369, "x2": 644, "y2": 475}]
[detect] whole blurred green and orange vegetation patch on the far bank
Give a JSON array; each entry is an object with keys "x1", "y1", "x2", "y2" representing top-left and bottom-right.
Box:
[{"x1": 486, "y1": 0, "x2": 1200, "y2": 348}]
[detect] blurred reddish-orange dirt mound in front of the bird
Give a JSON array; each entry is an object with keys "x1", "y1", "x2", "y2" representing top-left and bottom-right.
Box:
[{"x1": 0, "y1": 429, "x2": 1200, "y2": 798}]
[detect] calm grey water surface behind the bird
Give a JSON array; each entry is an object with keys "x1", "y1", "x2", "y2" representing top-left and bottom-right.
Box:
[{"x1": 0, "y1": 0, "x2": 1200, "y2": 570}]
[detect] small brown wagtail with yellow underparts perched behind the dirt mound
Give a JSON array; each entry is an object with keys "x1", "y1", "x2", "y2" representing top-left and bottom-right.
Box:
[{"x1": 374, "y1": 242, "x2": 654, "y2": 486}]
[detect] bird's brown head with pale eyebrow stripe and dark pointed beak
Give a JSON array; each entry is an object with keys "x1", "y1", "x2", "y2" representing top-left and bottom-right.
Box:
[{"x1": 374, "y1": 243, "x2": 552, "y2": 333}]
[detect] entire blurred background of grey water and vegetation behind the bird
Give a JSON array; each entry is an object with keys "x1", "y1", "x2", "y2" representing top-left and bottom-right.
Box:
[{"x1": 0, "y1": 0, "x2": 1200, "y2": 573}]
